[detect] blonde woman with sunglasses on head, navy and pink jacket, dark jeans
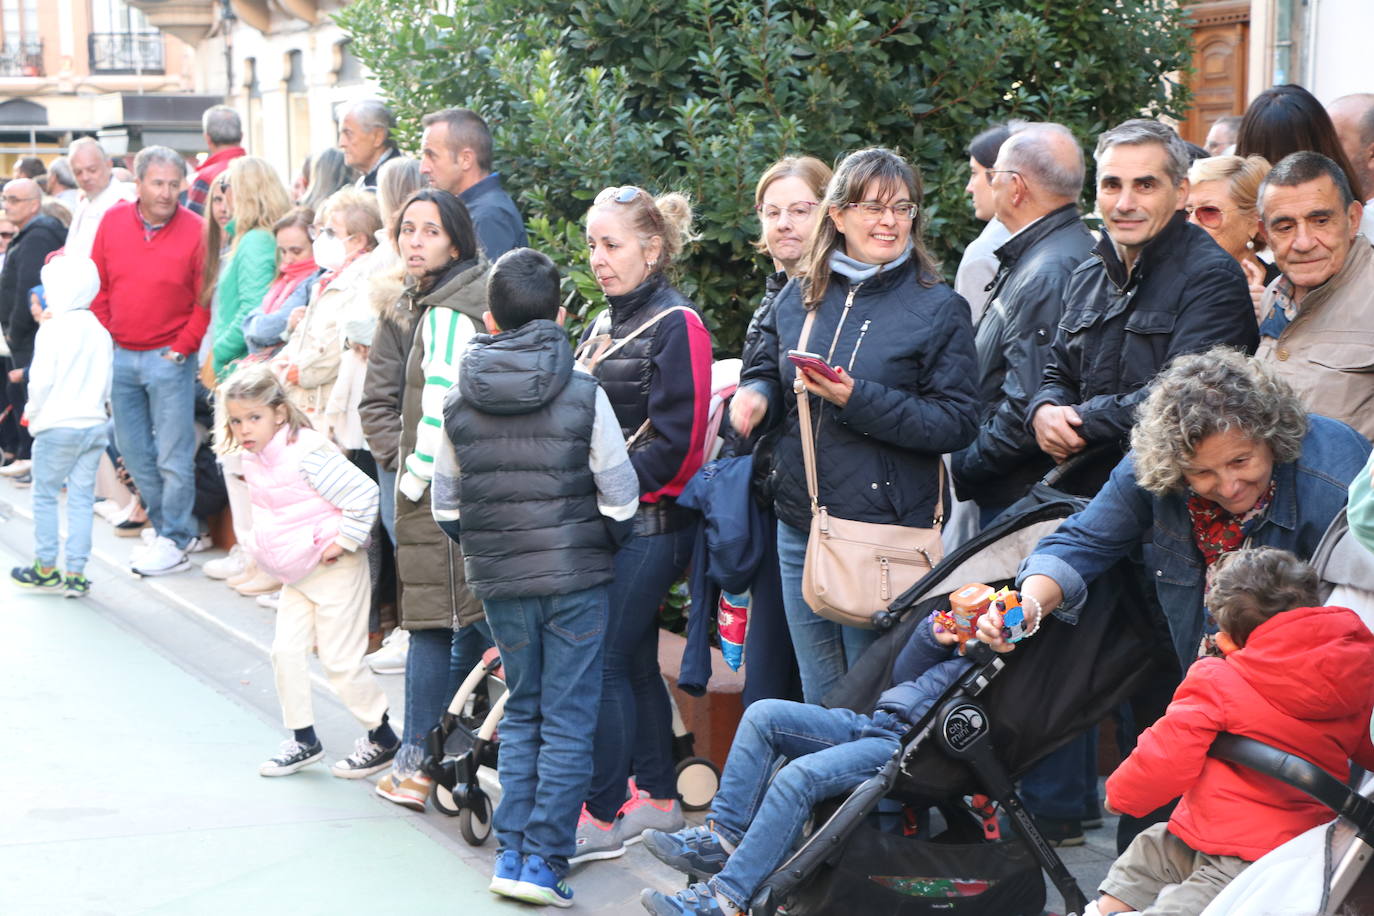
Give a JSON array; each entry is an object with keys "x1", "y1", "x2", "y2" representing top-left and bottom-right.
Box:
[{"x1": 569, "y1": 187, "x2": 712, "y2": 864}]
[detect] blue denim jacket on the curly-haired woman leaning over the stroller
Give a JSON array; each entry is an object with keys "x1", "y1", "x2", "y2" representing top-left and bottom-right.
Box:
[{"x1": 1017, "y1": 415, "x2": 1370, "y2": 670}]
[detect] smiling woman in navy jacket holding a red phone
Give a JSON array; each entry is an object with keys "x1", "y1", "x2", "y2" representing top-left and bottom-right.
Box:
[{"x1": 731, "y1": 148, "x2": 978, "y2": 703}]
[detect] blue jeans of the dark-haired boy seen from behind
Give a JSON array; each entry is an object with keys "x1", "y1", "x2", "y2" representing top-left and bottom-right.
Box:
[{"x1": 482, "y1": 585, "x2": 610, "y2": 875}]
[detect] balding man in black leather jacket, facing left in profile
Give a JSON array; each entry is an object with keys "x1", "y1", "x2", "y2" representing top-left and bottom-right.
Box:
[{"x1": 954, "y1": 124, "x2": 1092, "y2": 526}]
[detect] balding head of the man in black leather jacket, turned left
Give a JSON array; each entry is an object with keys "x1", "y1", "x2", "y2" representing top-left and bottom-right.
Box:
[{"x1": 992, "y1": 121, "x2": 1083, "y2": 232}]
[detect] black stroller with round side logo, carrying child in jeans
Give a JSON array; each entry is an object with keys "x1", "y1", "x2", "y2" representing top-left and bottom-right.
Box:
[{"x1": 750, "y1": 458, "x2": 1178, "y2": 916}]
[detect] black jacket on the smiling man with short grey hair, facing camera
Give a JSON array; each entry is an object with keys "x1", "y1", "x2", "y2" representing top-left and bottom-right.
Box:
[{"x1": 1025, "y1": 210, "x2": 1260, "y2": 449}]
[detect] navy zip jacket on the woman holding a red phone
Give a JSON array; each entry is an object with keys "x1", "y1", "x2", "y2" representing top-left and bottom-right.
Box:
[{"x1": 743, "y1": 261, "x2": 978, "y2": 530}]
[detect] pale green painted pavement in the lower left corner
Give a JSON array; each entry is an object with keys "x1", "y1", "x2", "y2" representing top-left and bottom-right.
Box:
[{"x1": 0, "y1": 549, "x2": 522, "y2": 916}]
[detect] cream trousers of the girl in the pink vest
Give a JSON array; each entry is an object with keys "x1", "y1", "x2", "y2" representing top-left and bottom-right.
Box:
[{"x1": 272, "y1": 551, "x2": 386, "y2": 731}]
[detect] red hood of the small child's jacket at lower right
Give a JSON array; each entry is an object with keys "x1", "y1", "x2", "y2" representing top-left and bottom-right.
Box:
[{"x1": 1227, "y1": 607, "x2": 1374, "y2": 721}]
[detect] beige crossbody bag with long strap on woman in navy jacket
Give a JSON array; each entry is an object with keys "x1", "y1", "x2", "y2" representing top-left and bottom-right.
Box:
[{"x1": 793, "y1": 310, "x2": 944, "y2": 629}]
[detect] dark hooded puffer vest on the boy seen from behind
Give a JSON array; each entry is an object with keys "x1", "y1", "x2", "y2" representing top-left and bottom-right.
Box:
[{"x1": 444, "y1": 320, "x2": 616, "y2": 599}]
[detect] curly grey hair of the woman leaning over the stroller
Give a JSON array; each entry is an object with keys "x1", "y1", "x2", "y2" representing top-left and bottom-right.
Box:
[{"x1": 1131, "y1": 346, "x2": 1307, "y2": 496}]
